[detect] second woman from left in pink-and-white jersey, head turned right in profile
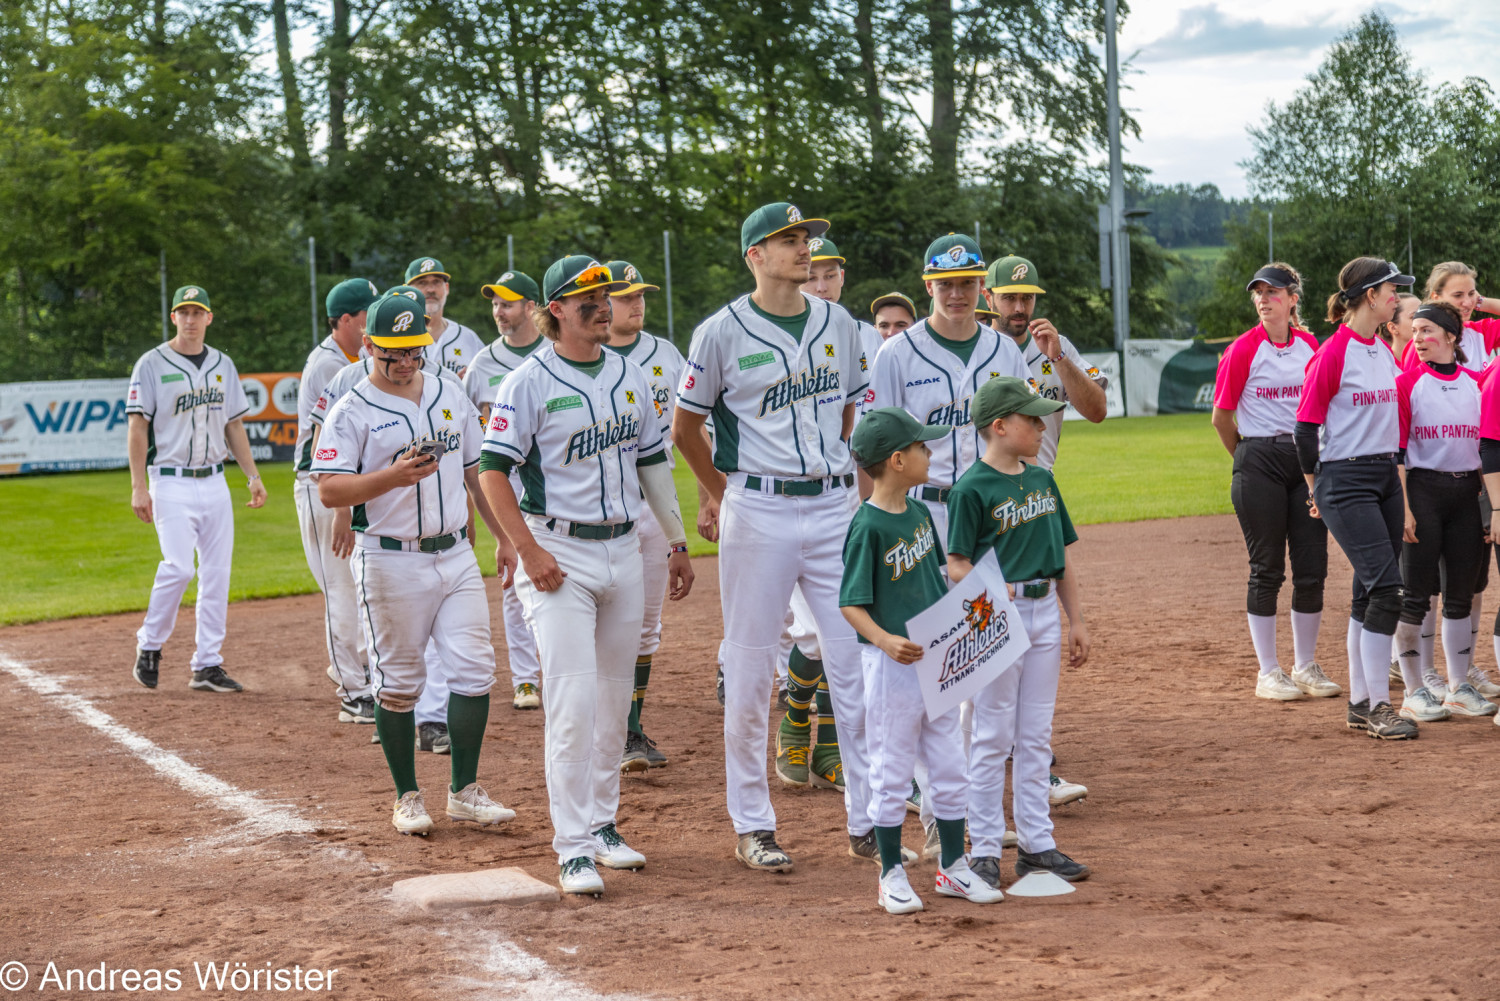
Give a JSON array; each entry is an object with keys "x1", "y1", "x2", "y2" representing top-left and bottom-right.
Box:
[{"x1": 1293, "y1": 257, "x2": 1418, "y2": 740}]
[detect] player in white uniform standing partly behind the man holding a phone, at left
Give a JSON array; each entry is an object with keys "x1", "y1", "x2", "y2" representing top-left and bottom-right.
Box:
[{"x1": 293, "y1": 278, "x2": 380, "y2": 723}]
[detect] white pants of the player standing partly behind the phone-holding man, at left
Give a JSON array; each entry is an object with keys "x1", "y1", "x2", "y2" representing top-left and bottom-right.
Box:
[{"x1": 293, "y1": 473, "x2": 371, "y2": 699}]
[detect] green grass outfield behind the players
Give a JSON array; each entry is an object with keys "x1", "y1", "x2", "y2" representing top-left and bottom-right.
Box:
[{"x1": 0, "y1": 414, "x2": 1230, "y2": 624}]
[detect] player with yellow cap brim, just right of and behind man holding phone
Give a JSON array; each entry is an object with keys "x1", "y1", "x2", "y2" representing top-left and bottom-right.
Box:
[{"x1": 464, "y1": 272, "x2": 543, "y2": 710}]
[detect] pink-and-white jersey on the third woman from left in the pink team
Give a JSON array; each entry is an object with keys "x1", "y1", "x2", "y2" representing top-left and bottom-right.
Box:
[{"x1": 1397, "y1": 365, "x2": 1479, "y2": 473}]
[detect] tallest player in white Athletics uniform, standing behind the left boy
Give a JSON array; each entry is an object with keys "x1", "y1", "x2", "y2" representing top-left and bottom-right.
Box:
[{"x1": 672, "y1": 201, "x2": 872, "y2": 872}]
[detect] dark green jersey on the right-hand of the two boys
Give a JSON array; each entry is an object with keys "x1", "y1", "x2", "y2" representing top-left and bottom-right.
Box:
[{"x1": 948, "y1": 461, "x2": 1079, "y2": 581}]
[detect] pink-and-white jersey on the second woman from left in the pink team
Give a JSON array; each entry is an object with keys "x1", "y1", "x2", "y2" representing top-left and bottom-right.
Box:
[{"x1": 1298, "y1": 324, "x2": 1401, "y2": 462}]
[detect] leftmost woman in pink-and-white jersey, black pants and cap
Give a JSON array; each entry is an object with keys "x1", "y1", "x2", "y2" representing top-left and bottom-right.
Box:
[{"x1": 1212, "y1": 263, "x2": 1344, "y2": 702}]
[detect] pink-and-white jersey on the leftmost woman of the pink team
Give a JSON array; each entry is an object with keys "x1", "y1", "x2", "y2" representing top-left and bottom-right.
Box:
[{"x1": 1214, "y1": 326, "x2": 1317, "y2": 438}]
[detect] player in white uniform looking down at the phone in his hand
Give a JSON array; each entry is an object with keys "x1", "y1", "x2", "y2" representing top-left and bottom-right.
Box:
[{"x1": 312, "y1": 296, "x2": 516, "y2": 834}]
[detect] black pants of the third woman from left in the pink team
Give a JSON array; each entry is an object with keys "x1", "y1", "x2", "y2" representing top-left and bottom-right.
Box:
[{"x1": 1401, "y1": 468, "x2": 1488, "y2": 623}]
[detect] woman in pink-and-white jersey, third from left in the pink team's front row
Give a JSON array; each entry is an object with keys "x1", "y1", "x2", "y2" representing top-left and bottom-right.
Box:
[{"x1": 1397, "y1": 303, "x2": 1497, "y2": 722}]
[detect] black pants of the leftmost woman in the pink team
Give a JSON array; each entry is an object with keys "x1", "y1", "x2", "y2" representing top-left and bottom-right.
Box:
[{"x1": 1229, "y1": 435, "x2": 1328, "y2": 615}]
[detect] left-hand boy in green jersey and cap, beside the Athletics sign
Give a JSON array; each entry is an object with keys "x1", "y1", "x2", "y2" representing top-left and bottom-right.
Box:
[{"x1": 839, "y1": 407, "x2": 1005, "y2": 914}]
